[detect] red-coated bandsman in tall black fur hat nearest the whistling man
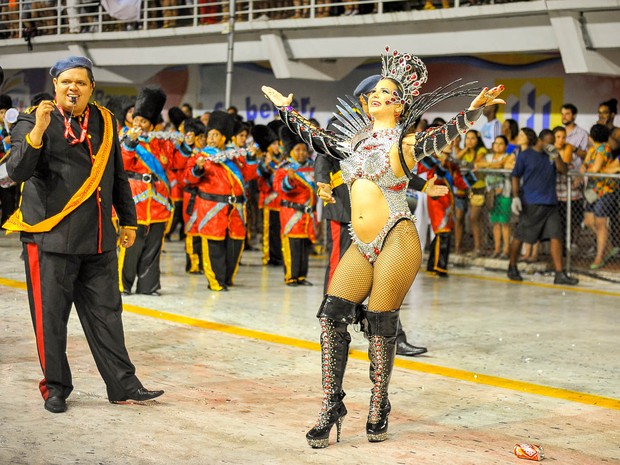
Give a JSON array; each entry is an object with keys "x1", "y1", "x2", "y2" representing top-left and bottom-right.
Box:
[{"x1": 119, "y1": 87, "x2": 180, "y2": 296}]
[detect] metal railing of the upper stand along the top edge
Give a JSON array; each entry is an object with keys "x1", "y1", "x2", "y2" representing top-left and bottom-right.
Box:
[{"x1": 0, "y1": 0, "x2": 527, "y2": 40}]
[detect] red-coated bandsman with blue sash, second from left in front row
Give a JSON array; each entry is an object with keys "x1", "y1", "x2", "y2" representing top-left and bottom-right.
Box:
[{"x1": 184, "y1": 111, "x2": 256, "y2": 291}]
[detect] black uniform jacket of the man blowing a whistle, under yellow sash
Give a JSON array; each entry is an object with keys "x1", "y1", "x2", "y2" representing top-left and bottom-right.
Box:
[{"x1": 7, "y1": 104, "x2": 137, "y2": 254}]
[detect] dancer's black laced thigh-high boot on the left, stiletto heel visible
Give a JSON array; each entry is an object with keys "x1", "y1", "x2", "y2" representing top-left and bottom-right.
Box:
[{"x1": 306, "y1": 295, "x2": 362, "y2": 449}]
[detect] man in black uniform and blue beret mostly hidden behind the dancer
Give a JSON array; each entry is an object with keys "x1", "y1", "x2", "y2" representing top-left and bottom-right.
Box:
[{"x1": 314, "y1": 74, "x2": 447, "y2": 357}]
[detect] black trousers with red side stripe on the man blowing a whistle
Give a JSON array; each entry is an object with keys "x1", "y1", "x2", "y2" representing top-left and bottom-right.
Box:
[{"x1": 24, "y1": 244, "x2": 142, "y2": 401}]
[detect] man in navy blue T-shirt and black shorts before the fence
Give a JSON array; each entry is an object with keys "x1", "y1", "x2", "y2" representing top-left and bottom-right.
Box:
[{"x1": 508, "y1": 128, "x2": 579, "y2": 285}]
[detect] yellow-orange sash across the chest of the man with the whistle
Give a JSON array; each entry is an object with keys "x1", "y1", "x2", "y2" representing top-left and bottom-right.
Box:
[{"x1": 3, "y1": 107, "x2": 114, "y2": 234}]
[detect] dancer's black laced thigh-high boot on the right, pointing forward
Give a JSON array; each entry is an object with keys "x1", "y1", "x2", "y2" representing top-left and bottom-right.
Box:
[{"x1": 365, "y1": 310, "x2": 400, "y2": 442}]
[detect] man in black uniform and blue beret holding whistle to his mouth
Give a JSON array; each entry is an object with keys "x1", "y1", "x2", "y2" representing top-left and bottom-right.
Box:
[{"x1": 4, "y1": 56, "x2": 163, "y2": 413}]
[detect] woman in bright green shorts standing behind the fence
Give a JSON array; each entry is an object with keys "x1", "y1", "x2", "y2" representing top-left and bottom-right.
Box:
[{"x1": 477, "y1": 135, "x2": 516, "y2": 260}]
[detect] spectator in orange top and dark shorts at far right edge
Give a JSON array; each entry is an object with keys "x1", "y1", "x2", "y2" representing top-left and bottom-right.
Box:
[{"x1": 580, "y1": 124, "x2": 620, "y2": 270}]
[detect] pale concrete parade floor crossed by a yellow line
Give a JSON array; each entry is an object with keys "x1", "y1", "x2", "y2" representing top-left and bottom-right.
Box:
[{"x1": 0, "y1": 236, "x2": 620, "y2": 465}]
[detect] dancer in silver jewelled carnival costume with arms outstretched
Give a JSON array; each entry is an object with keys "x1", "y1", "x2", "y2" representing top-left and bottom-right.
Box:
[{"x1": 262, "y1": 48, "x2": 504, "y2": 448}]
